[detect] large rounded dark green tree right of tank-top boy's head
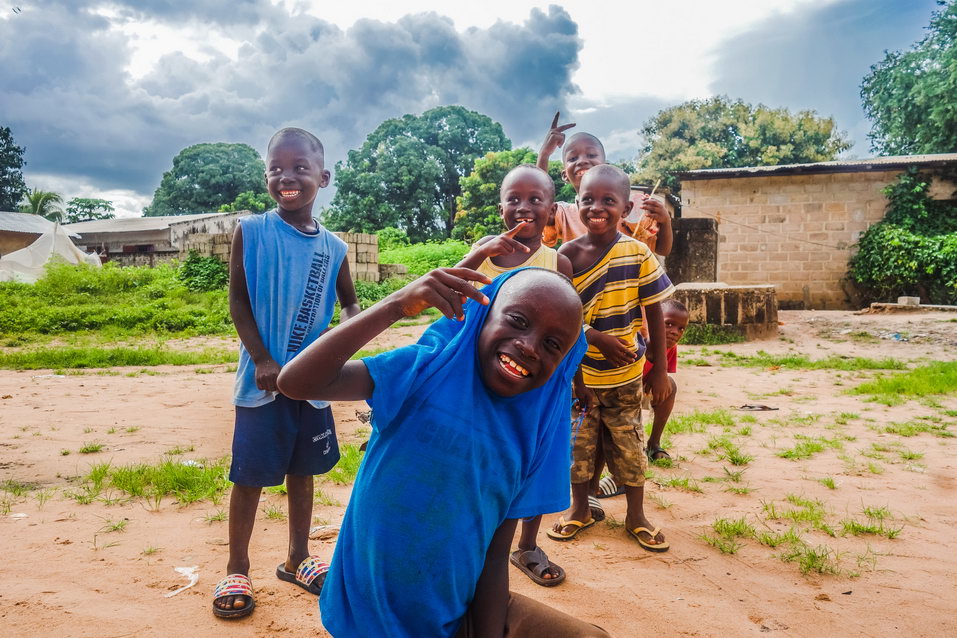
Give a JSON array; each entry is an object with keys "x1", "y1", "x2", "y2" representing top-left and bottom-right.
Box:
[{"x1": 326, "y1": 106, "x2": 512, "y2": 241}]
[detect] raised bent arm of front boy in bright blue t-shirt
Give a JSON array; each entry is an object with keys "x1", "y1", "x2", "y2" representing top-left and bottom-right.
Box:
[{"x1": 278, "y1": 268, "x2": 489, "y2": 401}]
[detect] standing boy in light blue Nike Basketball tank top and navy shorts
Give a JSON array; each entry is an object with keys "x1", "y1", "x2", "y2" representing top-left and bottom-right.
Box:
[{"x1": 213, "y1": 128, "x2": 359, "y2": 618}]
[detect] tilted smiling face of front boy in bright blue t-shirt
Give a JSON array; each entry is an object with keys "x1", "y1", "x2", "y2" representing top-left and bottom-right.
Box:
[{"x1": 478, "y1": 270, "x2": 582, "y2": 397}]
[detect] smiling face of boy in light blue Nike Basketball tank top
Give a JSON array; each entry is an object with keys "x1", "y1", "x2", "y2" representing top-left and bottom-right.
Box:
[{"x1": 266, "y1": 135, "x2": 329, "y2": 213}]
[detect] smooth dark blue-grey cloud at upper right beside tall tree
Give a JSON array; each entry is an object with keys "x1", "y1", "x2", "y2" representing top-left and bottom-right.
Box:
[{"x1": 711, "y1": 0, "x2": 936, "y2": 157}]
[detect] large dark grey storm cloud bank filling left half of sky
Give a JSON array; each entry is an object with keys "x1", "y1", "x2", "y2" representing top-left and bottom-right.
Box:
[{"x1": 0, "y1": 0, "x2": 581, "y2": 202}]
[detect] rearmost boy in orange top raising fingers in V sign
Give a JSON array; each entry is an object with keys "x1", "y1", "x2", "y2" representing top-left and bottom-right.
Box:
[{"x1": 538, "y1": 113, "x2": 674, "y2": 257}]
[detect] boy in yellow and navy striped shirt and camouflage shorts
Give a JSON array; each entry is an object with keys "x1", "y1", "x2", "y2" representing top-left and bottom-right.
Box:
[{"x1": 547, "y1": 164, "x2": 674, "y2": 552}]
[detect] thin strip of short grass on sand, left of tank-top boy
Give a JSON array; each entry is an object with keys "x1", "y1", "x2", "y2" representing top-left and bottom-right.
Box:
[{"x1": 0, "y1": 347, "x2": 239, "y2": 370}]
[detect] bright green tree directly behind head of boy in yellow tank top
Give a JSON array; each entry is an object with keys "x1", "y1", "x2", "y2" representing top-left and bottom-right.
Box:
[{"x1": 452, "y1": 146, "x2": 575, "y2": 242}]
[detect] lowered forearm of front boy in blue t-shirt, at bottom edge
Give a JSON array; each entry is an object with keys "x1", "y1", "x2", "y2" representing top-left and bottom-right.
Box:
[{"x1": 469, "y1": 518, "x2": 518, "y2": 638}]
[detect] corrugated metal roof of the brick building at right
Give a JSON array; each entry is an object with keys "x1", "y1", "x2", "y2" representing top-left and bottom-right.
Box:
[{"x1": 677, "y1": 153, "x2": 957, "y2": 180}]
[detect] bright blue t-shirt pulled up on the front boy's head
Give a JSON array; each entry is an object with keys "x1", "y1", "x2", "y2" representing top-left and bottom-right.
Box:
[{"x1": 320, "y1": 271, "x2": 585, "y2": 638}]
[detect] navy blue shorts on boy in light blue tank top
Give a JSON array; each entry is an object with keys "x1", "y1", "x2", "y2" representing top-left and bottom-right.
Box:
[{"x1": 229, "y1": 394, "x2": 339, "y2": 487}]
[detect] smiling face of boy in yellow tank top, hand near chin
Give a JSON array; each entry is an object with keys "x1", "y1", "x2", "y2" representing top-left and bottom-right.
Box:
[{"x1": 498, "y1": 166, "x2": 555, "y2": 241}]
